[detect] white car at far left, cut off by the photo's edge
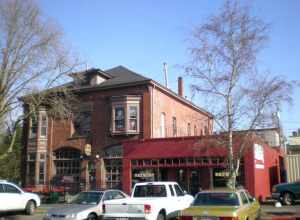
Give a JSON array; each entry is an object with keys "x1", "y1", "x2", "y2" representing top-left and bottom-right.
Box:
[{"x1": 0, "y1": 180, "x2": 41, "y2": 215}]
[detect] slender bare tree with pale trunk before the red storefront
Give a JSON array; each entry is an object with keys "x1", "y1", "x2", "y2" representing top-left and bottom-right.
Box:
[{"x1": 185, "y1": 1, "x2": 295, "y2": 187}]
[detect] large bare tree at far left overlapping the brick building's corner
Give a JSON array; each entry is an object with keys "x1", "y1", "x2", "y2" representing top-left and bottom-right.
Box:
[{"x1": 0, "y1": 0, "x2": 78, "y2": 156}]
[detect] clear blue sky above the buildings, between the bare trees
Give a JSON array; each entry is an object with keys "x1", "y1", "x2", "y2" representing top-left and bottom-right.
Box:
[{"x1": 39, "y1": 0, "x2": 300, "y2": 135}]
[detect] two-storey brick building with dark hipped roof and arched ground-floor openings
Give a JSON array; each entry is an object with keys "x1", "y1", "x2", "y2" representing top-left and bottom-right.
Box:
[{"x1": 22, "y1": 66, "x2": 213, "y2": 191}]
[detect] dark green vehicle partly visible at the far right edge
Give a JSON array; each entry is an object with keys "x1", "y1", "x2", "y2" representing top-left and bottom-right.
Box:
[{"x1": 272, "y1": 180, "x2": 300, "y2": 205}]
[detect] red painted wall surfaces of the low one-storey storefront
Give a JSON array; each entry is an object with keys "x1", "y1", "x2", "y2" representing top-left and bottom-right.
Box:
[{"x1": 122, "y1": 136, "x2": 282, "y2": 199}]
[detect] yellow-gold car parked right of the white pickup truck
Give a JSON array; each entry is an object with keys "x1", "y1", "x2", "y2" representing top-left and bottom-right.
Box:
[{"x1": 179, "y1": 189, "x2": 260, "y2": 220}]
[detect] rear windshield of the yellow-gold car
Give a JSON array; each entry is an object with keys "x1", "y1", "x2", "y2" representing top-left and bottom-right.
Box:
[{"x1": 193, "y1": 192, "x2": 239, "y2": 206}]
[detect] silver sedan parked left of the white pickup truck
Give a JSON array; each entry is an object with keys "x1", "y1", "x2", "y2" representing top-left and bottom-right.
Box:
[{"x1": 43, "y1": 190, "x2": 128, "y2": 220}]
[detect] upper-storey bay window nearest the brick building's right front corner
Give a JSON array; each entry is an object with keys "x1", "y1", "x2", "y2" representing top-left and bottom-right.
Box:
[{"x1": 111, "y1": 96, "x2": 141, "y2": 135}]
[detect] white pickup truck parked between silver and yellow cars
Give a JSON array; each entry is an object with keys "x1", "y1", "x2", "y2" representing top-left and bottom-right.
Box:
[{"x1": 102, "y1": 182, "x2": 194, "y2": 220}]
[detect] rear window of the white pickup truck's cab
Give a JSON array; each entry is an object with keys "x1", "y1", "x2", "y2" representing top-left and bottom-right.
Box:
[{"x1": 133, "y1": 185, "x2": 167, "y2": 197}]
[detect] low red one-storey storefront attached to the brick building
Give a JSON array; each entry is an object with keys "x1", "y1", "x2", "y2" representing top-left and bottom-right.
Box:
[{"x1": 122, "y1": 135, "x2": 283, "y2": 198}]
